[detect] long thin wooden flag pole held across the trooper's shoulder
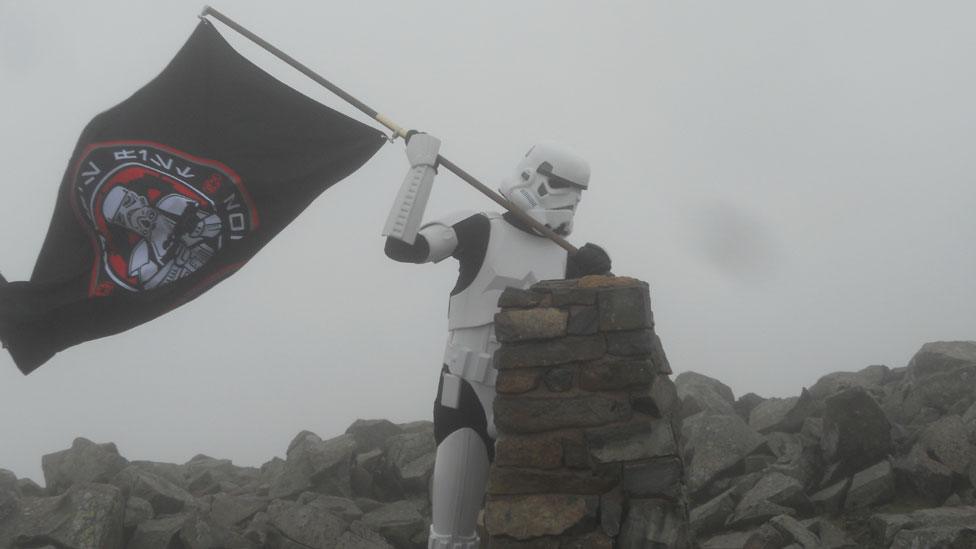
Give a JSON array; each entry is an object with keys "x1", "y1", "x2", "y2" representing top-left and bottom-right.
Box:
[{"x1": 200, "y1": 6, "x2": 578, "y2": 255}]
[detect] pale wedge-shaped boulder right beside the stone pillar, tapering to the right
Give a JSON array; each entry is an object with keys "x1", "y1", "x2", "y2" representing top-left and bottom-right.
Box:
[{"x1": 682, "y1": 412, "x2": 768, "y2": 497}]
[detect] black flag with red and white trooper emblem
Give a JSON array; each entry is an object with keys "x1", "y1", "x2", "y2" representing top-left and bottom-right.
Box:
[{"x1": 0, "y1": 21, "x2": 384, "y2": 374}]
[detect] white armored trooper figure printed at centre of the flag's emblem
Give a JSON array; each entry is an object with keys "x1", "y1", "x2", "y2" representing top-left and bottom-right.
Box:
[{"x1": 102, "y1": 187, "x2": 221, "y2": 290}]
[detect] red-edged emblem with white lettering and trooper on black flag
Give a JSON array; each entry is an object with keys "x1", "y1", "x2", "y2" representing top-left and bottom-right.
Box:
[{"x1": 73, "y1": 142, "x2": 258, "y2": 296}]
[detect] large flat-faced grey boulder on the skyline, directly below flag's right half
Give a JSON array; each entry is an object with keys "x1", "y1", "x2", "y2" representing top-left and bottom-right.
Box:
[{"x1": 268, "y1": 431, "x2": 357, "y2": 499}]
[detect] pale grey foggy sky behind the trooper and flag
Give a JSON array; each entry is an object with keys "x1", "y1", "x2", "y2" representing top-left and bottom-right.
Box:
[{"x1": 0, "y1": 0, "x2": 976, "y2": 482}]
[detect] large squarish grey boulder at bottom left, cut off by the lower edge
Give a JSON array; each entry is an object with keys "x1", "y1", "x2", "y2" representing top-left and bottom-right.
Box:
[{"x1": 14, "y1": 482, "x2": 125, "y2": 549}]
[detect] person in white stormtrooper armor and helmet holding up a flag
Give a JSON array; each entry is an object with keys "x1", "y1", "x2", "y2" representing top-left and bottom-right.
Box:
[{"x1": 383, "y1": 133, "x2": 610, "y2": 549}]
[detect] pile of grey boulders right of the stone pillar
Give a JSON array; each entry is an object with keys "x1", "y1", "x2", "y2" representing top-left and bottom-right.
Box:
[{"x1": 675, "y1": 342, "x2": 976, "y2": 549}]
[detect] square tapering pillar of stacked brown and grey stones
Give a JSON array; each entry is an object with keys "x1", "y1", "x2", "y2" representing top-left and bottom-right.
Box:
[{"x1": 485, "y1": 276, "x2": 689, "y2": 549}]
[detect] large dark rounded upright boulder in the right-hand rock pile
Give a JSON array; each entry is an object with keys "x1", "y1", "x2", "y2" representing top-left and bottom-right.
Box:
[{"x1": 821, "y1": 387, "x2": 892, "y2": 472}]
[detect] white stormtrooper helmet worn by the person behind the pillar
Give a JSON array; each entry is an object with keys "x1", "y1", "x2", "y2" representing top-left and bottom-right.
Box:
[{"x1": 499, "y1": 143, "x2": 590, "y2": 236}]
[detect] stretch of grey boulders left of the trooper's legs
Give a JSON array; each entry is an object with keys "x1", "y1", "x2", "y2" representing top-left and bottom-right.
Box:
[{"x1": 0, "y1": 420, "x2": 435, "y2": 549}]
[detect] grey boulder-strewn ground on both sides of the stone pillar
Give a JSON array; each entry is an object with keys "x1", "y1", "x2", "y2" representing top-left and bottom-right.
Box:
[{"x1": 0, "y1": 342, "x2": 976, "y2": 549}]
